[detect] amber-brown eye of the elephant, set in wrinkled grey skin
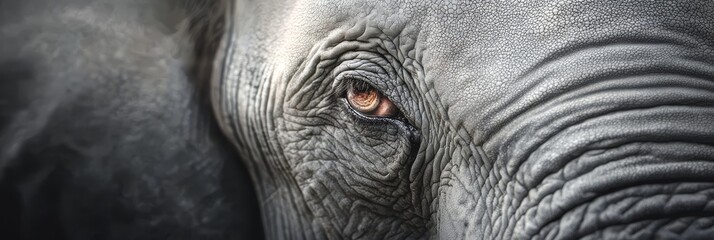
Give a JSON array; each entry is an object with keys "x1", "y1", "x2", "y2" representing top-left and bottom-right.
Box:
[{"x1": 347, "y1": 80, "x2": 399, "y2": 117}]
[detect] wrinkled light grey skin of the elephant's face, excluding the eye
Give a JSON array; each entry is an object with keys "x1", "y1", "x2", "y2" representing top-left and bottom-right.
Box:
[{"x1": 211, "y1": 0, "x2": 714, "y2": 239}]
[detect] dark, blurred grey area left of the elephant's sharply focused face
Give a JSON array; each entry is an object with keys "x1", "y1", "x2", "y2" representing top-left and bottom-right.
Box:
[{"x1": 0, "y1": 0, "x2": 260, "y2": 239}]
